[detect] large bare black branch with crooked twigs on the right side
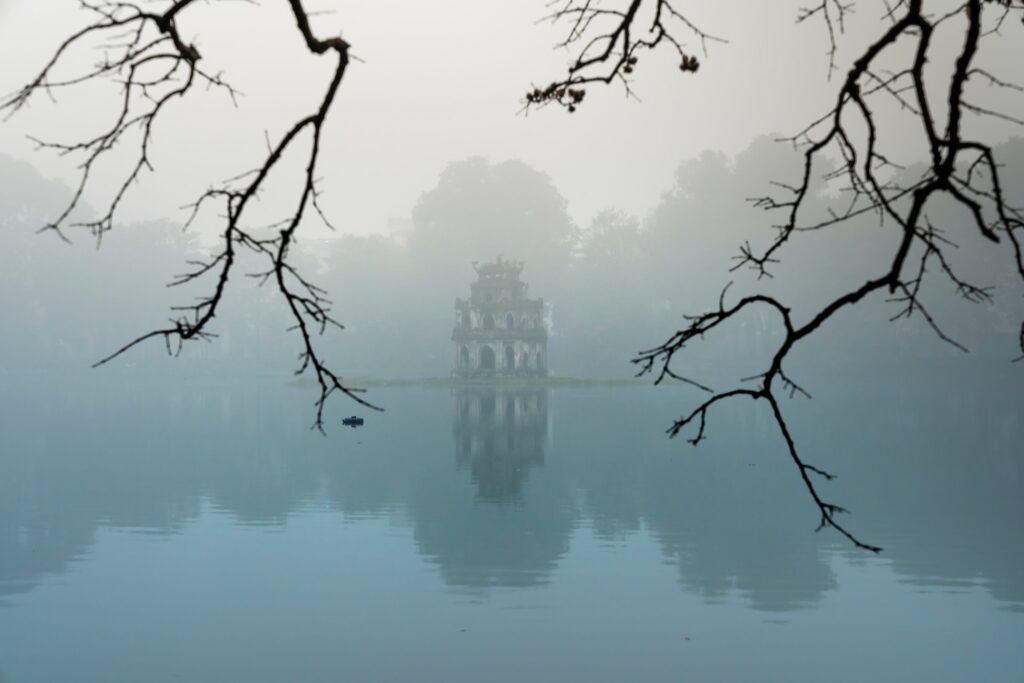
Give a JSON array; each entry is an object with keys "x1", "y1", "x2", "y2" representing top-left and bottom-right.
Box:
[{"x1": 634, "y1": 0, "x2": 1024, "y2": 552}]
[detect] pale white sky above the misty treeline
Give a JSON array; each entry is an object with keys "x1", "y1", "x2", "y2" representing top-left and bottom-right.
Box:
[{"x1": 0, "y1": 0, "x2": 1024, "y2": 233}]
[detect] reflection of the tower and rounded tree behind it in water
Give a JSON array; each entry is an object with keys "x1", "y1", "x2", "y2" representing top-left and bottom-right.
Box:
[{"x1": 410, "y1": 387, "x2": 575, "y2": 589}]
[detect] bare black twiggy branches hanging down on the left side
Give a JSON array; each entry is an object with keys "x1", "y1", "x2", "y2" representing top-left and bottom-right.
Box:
[{"x1": 0, "y1": 0, "x2": 376, "y2": 430}]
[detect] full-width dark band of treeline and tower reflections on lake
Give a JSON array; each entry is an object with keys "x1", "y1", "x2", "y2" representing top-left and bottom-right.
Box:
[{"x1": 0, "y1": 374, "x2": 1024, "y2": 612}]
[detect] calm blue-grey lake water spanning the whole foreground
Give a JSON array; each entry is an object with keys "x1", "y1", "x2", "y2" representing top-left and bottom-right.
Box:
[{"x1": 0, "y1": 374, "x2": 1024, "y2": 683}]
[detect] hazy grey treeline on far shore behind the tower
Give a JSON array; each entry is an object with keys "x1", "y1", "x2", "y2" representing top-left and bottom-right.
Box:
[{"x1": 0, "y1": 136, "x2": 1024, "y2": 378}]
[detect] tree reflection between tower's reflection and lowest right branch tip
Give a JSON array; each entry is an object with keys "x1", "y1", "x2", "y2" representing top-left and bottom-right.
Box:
[{"x1": 559, "y1": 394, "x2": 837, "y2": 611}]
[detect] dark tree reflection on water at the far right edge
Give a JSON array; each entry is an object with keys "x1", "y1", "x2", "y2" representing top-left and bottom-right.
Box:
[{"x1": 823, "y1": 384, "x2": 1024, "y2": 609}]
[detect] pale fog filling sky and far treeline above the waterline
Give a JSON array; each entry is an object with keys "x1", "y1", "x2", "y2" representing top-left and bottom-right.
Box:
[{"x1": 0, "y1": 0, "x2": 1022, "y2": 377}]
